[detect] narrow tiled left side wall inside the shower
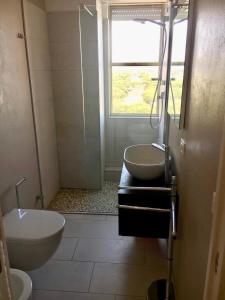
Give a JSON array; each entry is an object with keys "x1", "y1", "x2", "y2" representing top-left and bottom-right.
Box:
[{"x1": 24, "y1": 0, "x2": 59, "y2": 206}]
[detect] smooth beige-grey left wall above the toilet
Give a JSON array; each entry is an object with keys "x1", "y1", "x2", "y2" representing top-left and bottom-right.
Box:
[{"x1": 0, "y1": 0, "x2": 40, "y2": 212}]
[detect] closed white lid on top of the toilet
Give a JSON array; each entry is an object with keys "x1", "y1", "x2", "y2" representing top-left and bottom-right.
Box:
[{"x1": 3, "y1": 209, "x2": 65, "y2": 242}]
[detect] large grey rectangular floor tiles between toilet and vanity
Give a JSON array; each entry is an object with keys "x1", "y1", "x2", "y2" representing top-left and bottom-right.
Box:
[{"x1": 29, "y1": 214, "x2": 166, "y2": 300}]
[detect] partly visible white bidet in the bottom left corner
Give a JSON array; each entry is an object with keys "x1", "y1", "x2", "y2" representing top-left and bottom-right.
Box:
[{"x1": 0, "y1": 269, "x2": 32, "y2": 300}]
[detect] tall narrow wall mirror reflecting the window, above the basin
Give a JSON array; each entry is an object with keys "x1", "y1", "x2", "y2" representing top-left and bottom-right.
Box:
[{"x1": 168, "y1": 4, "x2": 191, "y2": 128}]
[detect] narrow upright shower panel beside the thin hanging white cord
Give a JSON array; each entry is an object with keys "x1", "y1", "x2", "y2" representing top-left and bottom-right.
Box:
[{"x1": 79, "y1": 5, "x2": 102, "y2": 189}]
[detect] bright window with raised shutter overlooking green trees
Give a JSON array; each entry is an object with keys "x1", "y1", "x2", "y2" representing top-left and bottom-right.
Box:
[{"x1": 110, "y1": 5, "x2": 162, "y2": 116}]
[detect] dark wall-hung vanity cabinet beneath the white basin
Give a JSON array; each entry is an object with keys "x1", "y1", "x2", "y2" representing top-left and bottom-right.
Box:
[{"x1": 118, "y1": 166, "x2": 175, "y2": 238}]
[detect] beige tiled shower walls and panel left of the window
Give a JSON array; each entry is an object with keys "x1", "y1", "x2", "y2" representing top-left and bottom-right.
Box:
[{"x1": 23, "y1": 0, "x2": 104, "y2": 206}]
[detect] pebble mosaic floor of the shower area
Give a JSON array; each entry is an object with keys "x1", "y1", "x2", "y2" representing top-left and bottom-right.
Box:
[{"x1": 48, "y1": 182, "x2": 118, "y2": 215}]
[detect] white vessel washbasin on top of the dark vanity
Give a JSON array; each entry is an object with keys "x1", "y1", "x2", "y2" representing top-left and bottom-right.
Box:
[{"x1": 124, "y1": 144, "x2": 165, "y2": 180}]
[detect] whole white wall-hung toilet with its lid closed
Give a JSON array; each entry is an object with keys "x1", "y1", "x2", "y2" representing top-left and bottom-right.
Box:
[{"x1": 3, "y1": 209, "x2": 65, "y2": 271}]
